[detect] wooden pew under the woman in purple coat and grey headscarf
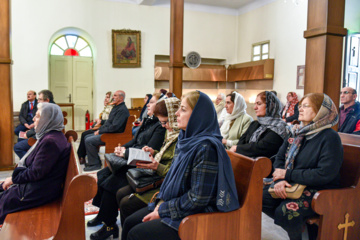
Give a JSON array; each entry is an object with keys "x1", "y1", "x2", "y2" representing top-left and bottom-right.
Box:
[{"x1": 0, "y1": 133, "x2": 97, "y2": 240}]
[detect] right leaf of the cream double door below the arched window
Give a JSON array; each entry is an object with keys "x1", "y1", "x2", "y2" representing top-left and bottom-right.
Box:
[{"x1": 73, "y1": 57, "x2": 93, "y2": 130}]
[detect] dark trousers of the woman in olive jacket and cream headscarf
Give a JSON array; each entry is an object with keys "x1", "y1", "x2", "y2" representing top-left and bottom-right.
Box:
[{"x1": 116, "y1": 185, "x2": 147, "y2": 226}]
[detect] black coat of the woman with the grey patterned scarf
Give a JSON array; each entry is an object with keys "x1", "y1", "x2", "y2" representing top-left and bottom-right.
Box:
[{"x1": 236, "y1": 121, "x2": 284, "y2": 159}]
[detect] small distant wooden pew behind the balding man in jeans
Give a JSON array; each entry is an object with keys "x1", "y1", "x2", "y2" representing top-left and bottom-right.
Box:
[{"x1": 101, "y1": 116, "x2": 135, "y2": 153}]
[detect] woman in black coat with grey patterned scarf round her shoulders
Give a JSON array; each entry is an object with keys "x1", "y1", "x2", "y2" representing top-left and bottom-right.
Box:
[{"x1": 230, "y1": 91, "x2": 287, "y2": 162}]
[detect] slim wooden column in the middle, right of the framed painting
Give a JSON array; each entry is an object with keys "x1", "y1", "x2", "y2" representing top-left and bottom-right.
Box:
[{"x1": 169, "y1": 0, "x2": 184, "y2": 98}]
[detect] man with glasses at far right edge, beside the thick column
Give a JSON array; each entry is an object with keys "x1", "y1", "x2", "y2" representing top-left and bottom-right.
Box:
[{"x1": 338, "y1": 87, "x2": 360, "y2": 133}]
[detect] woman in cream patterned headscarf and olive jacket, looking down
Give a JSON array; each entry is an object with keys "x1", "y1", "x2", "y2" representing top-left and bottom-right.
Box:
[{"x1": 116, "y1": 97, "x2": 180, "y2": 228}]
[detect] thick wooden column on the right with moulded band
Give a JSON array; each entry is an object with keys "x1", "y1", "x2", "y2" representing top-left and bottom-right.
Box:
[{"x1": 304, "y1": 0, "x2": 347, "y2": 106}]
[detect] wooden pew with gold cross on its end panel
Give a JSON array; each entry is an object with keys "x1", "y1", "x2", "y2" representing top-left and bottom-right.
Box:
[{"x1": 308, "y1": 133, "x2": 360, "y2": 240}]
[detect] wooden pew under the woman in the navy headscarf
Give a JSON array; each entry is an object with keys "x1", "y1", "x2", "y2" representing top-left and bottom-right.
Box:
[{"x1": 179, "y1": 151, "x2": 271, "y2": 240}]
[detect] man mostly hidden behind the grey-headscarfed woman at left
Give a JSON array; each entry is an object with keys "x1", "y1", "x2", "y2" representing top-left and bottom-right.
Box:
[{"x1": 14, "y1": 90, "x2": 55, "y2": 159}]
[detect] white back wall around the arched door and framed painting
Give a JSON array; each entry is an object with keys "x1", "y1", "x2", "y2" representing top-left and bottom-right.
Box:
[{"x1": 11, "y1": 0, "x2": 236, "y2": 115}]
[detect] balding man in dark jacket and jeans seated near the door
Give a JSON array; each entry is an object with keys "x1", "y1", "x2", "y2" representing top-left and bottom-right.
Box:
[{"x1": 84, "y1": 90, "x2": 130, "y2": 171}]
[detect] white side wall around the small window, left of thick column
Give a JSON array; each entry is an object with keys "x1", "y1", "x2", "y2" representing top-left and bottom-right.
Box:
[{"x1": 237, "y1": 0, "x2": 307, "y2": 102}]
